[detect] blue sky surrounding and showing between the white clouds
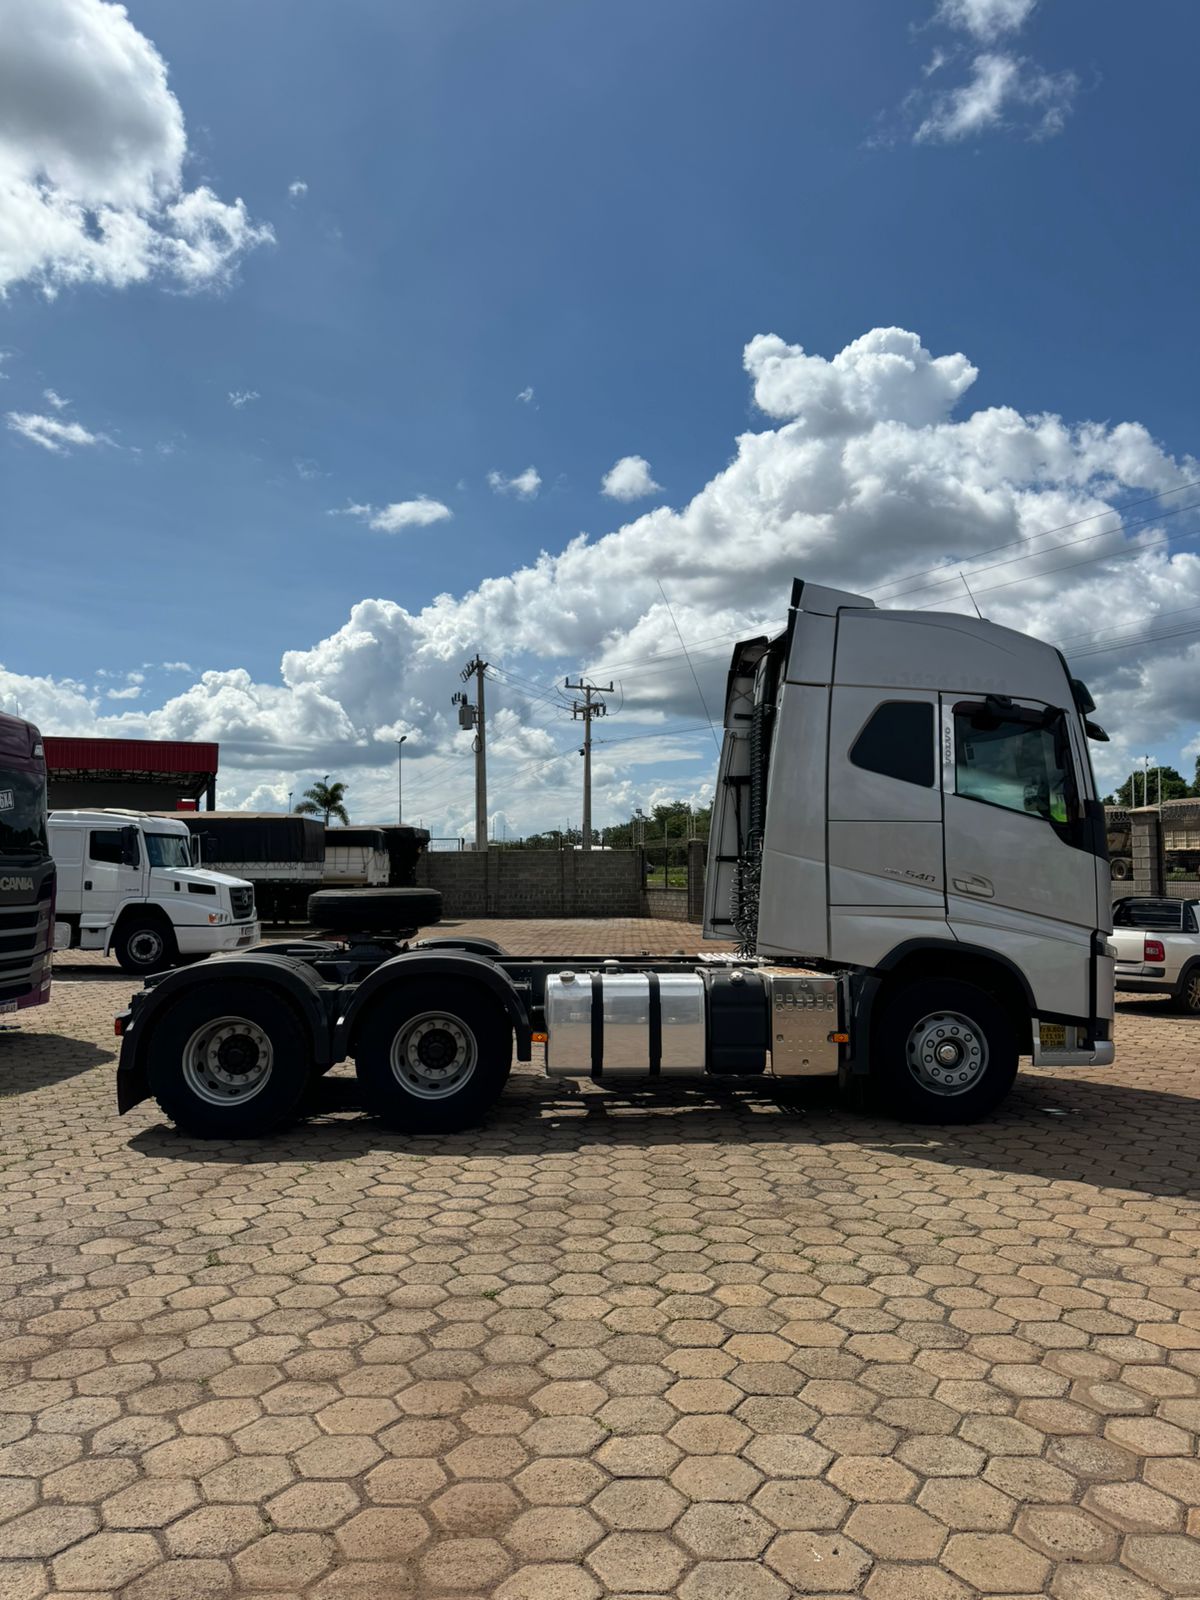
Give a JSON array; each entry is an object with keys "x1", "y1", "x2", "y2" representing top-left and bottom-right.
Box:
[{"x1": 0, "y1": 0, "x2": 1200, "y2": 830}]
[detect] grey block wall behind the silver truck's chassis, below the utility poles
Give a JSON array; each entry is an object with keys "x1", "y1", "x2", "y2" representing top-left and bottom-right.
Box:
[{"x1": 416, "y1": 850, "x2": 643, "y2": 917}]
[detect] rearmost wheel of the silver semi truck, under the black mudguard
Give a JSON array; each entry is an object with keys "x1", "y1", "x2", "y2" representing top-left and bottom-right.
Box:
[{"x1": 142, "y1": 982, "x2": 312, "y2": 1139}]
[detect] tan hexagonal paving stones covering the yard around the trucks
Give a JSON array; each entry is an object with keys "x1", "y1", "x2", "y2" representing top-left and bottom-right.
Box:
[{"x1": 0, "y1": 923, "x2": 1200, "y2": 1600}]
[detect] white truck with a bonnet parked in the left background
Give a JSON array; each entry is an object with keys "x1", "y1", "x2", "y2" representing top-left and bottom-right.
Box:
[{"x1": 48, "y1": 810, "x2": 259, "y2": 976}]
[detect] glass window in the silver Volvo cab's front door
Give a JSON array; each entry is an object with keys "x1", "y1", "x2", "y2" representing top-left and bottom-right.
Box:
[{"x1": 954, "y1": 710, "x2": 1069, "y2": 824}]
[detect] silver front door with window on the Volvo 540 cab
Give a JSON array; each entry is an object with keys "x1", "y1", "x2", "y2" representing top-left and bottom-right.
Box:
[{"x1": 941, "y1": 694, "x2": 1098, "y2": 1016}]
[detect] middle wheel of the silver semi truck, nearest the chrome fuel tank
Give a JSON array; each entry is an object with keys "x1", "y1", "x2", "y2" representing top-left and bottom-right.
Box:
[{"x1": 354, "y1": 981, "x2": 512, "y2": 1133}]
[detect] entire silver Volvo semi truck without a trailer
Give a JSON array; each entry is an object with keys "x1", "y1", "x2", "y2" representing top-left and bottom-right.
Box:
[{"x1": 117, "y1": 582, "x2": 1114, "y2": 1138}]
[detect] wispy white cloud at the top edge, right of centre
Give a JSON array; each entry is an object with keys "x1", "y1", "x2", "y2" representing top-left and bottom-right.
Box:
[{"x1": 904, "y1": 0, "x2": 1080, "y2": 144}]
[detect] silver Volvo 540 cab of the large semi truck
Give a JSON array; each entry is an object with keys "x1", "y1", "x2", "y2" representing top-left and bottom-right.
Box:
[{"x1": 706, "y1": 582, "x2": 1114, "y2": 1066}]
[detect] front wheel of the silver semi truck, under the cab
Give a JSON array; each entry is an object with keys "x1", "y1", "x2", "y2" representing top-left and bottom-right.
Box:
[{"x1": 875, "y1": 979, "x2": 1018, "y2": 1123}]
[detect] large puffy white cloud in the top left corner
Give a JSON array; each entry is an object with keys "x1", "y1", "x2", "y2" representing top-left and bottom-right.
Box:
[{"x1": 0, "y1": 0, "x2": 274, "y2": 294}]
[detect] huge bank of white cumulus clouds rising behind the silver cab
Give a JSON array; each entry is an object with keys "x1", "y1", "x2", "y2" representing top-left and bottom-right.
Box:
[{"x1": 9, "y1": 328, "x2": 1200, "y2": 834}]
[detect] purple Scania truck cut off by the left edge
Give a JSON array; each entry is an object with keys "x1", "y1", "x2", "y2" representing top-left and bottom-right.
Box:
[{"x1": 0, "y1": 714, "x2": 54, "y2": 1016}]
